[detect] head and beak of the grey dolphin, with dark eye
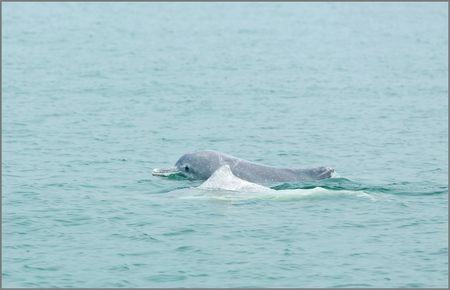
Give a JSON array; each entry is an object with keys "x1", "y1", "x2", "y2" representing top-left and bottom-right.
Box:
[{"x1": 152, "y1": 151, "x2": 222, "y2": 179}]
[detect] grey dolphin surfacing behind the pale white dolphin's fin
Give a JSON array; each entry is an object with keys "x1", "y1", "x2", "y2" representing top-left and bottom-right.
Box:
[{"x1": 152, "y1": 150, "x2": 334, "y2": 184}]
